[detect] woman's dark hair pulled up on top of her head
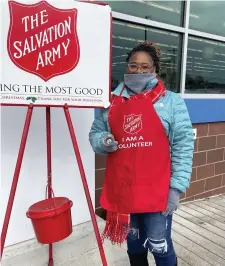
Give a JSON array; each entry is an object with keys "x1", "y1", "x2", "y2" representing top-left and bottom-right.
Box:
[{"x1": 126, "y1": 42, "x2": 161, "y2": 74}]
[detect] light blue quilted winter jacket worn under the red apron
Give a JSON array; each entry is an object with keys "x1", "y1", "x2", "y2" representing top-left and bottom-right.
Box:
[{"x1": 89, "y1": 79, "x2": 194, "y2": 192}]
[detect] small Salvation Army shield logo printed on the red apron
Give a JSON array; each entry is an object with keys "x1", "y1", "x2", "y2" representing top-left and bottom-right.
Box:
[{"x1": 123, "y1": 114, "x2": 142, "y2": 134}]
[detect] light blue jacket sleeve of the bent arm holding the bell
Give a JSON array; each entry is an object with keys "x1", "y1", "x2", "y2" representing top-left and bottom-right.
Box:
[{"x1": 89, "y1": 110, "x2": 109, "y2": 155}]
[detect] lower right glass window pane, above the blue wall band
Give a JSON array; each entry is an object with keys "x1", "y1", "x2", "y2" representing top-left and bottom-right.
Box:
[{"x1": 186, "y1": 36, "x2": 225, "y2": 94}]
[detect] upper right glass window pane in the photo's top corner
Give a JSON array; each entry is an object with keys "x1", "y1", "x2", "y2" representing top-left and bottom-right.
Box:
[{"x1": 189, "y1": 1, "x2": 225, "y2": 36}]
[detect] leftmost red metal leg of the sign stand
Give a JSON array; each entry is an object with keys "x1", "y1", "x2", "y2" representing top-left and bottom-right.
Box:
[{"x1": 1, "y1": 104, "x2": 33, "y2": 258}]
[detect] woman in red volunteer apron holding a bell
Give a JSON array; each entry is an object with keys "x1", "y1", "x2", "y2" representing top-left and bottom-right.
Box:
[{"x1": 89, "y1": 42, "x2": 194, "y2": 266}]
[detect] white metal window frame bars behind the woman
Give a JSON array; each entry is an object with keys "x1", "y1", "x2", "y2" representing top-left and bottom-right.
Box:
[{"x1": 112, "y1": 0, "x2": 225, "y2": 99}]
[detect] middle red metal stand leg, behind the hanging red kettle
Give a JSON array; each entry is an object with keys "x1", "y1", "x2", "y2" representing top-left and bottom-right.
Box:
[{"x1": 46, "y1": 107, "x2": 54, "y2": 266}]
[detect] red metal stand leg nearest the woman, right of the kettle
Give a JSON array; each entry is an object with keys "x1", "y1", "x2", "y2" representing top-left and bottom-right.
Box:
[{"x1": 64, "y1": 105, "x2": 107, "y2": 266}]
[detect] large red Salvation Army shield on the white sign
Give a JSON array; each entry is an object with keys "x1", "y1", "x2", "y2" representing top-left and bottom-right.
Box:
[{"x1": 8, "y1": 1, "x2": 80, "y2": 81}]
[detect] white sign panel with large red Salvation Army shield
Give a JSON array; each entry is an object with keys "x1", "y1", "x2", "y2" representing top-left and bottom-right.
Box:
[{"x1": 0, "y1": 0, "x2": 112, "y2": 107}]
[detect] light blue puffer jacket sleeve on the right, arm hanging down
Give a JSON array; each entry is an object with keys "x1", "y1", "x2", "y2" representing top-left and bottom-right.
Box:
[{"x1": 170, "y1": 95, "x2": 194, "y2": 193}]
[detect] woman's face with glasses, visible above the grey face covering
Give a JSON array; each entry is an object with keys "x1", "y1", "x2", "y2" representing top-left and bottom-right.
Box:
[{"x1": 127, "y1": 51, "x2": 156, "y2": 74}]
